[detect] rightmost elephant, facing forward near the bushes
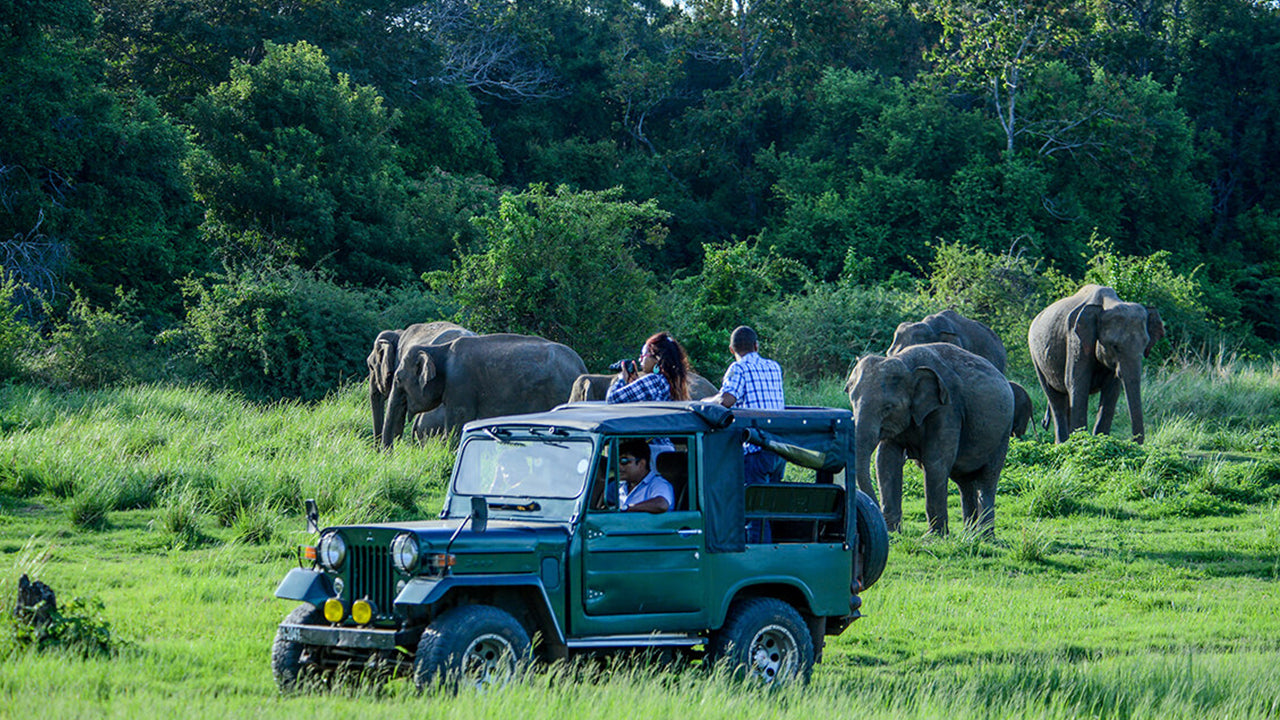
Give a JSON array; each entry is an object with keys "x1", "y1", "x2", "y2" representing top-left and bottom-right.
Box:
[{"x1": 1027, "y1": 284, "x2": 1165, "y2": 443}]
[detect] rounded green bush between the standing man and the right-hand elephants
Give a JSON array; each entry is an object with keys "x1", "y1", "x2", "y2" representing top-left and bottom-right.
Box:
[{"x1": 758, "y1": 283, "x2": 915, "y2": 380}]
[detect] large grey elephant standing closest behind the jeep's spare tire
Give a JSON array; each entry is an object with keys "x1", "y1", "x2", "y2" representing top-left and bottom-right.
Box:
[{"x1": 845, "y1": 342, "x2": 1014, "y2": 537}]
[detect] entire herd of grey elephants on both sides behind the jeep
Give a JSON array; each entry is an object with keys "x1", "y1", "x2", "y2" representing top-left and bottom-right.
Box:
[{"x1": 367, "y1": 284, "x2": 1165, "y2": 534}]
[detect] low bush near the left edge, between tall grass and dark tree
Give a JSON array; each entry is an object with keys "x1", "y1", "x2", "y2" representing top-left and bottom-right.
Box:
[{"x1": 31, "y1": 290, "x2": 160, "y2": 388}]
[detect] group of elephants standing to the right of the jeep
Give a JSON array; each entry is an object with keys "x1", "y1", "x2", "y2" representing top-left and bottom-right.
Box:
[{"x1": 845, "y1": 284, "x2": 1165, "y2": 536}]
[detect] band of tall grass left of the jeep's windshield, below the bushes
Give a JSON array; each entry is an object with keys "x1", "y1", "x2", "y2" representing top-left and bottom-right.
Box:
[{"x1": 0, "y1": 386, "x2": 452, "y2": 537}]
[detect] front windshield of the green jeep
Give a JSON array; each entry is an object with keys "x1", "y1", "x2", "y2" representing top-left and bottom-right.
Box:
[{"x1": 449, "y1": 434, "x2": 594, "y2": 519}]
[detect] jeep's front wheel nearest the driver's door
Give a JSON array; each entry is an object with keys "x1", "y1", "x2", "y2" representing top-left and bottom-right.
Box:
[{"x1": 413, "y1": 605, "x2": 530, "y2": 691}]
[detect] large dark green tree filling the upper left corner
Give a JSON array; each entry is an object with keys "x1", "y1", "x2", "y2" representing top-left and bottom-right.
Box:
[{"x1": 0, "y1": 0, "x2": 207, "y2": 314}]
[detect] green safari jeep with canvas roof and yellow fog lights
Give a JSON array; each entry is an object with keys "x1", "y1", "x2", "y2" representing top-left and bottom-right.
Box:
[{"x1": 271, "y1": 402, "x2": 888, "y2": 689}]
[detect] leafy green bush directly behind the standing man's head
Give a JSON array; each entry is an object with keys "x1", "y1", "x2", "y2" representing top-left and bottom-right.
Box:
[{"x1": 663, "y1": 242, "x2": 812, "y2": 369}]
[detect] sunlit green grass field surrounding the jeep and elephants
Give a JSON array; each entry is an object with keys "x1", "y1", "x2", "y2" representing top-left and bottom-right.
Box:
[{"x1": 0, "y1": 363, "x2": 1280, "y2": 719}]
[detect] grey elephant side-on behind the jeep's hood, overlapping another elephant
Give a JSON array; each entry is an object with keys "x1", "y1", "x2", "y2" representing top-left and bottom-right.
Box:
[{"x1": 373, "y1": 334, "x2": 586, "y2": 447}]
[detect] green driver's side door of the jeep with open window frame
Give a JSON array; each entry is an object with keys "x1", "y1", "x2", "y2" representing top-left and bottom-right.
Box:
[{"x1": 575, "y1": 438, "x2": 707, "y2": 625}]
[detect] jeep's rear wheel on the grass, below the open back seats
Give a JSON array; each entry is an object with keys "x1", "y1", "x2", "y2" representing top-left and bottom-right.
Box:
[{"x1": 709, "y1": 597, "x2": 814, "y2": 685}]
